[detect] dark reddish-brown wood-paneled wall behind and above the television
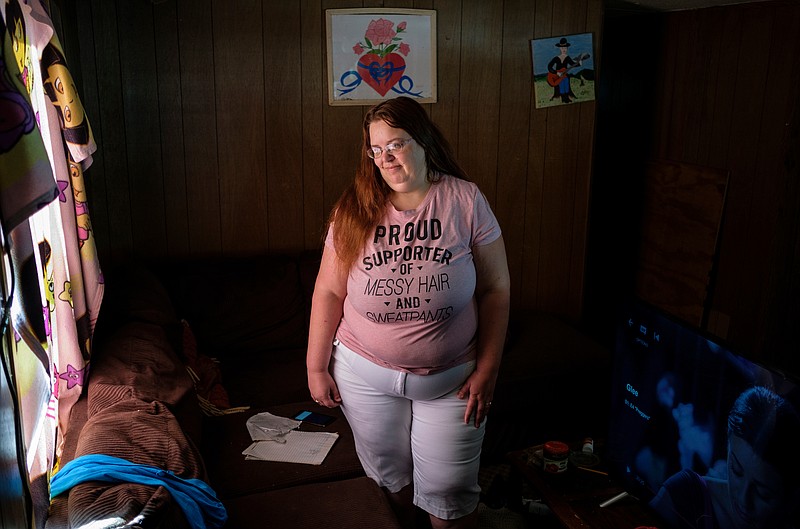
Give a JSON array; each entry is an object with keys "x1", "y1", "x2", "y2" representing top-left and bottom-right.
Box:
[{"x1": 651, "y1": 2, "x2": 800, "y2": 374}]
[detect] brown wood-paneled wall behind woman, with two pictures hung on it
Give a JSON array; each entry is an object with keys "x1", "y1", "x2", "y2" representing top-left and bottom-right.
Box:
[{"x1": 57, "y1": 0, "x2": 603, "y2": 319}]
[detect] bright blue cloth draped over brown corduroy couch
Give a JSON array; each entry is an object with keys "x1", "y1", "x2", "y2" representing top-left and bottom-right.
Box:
[{"x1": 50, "y1": 454, "x2": 228, "y2": 529}]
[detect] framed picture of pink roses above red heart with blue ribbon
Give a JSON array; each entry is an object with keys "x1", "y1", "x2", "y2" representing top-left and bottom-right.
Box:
[{"x1": 325, "y1": 8, "x2": 436, "y2": 105}]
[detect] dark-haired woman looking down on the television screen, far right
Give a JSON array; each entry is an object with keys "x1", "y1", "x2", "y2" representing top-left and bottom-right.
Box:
[{"x1": 650, "y1": 386, "x2": 800, "y2": 529}]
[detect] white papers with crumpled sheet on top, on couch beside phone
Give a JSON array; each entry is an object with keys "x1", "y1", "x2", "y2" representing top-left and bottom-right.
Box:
[{"x1": 242, "y1": 412, "x2": 339, "y2": 465}]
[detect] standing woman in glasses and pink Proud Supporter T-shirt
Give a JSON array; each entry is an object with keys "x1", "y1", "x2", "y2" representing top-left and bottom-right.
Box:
[{"x1": 307, "y1": 97, "x2": 509, "y2": 529}]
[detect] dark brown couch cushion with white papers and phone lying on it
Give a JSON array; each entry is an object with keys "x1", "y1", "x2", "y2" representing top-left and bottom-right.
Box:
[{"x1": 203, "y1": 402, "x2": 364, "y2": 498}]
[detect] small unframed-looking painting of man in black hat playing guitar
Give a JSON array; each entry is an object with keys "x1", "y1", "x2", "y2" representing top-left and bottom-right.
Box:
[{"x1": 531, "y1": 33, "x2": 594, "y2": 108}]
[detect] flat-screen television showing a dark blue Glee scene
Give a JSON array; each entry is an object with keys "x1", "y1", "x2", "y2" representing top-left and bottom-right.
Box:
[{"x1": 606, "y1": 299, "x2": 800, "y2": 529}]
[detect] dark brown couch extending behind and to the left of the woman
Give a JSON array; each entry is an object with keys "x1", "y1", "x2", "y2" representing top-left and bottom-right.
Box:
[{"x1": 47, "y1": 252, "x2": 610, "y2": 529}]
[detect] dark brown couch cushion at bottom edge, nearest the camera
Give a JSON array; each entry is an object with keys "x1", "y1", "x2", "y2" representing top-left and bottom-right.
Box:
[{"x1": 223, "y1": 477, "x2": 400, "y2": 529}]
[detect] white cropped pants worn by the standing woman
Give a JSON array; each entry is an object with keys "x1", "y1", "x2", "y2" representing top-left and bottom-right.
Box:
[{"x1": 332, "y1": 340, "x2": 486, "y2": 519}]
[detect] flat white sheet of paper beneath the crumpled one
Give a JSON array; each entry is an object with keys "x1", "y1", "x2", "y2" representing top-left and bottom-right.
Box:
[{"x1": 242, "y1": 430, "x2": 339, "y2": 465}]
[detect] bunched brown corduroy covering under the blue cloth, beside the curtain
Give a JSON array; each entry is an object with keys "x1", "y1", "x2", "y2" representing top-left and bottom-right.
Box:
[{"x1": 46, "y1": 321, "x2": 207, "y2": 529}]
